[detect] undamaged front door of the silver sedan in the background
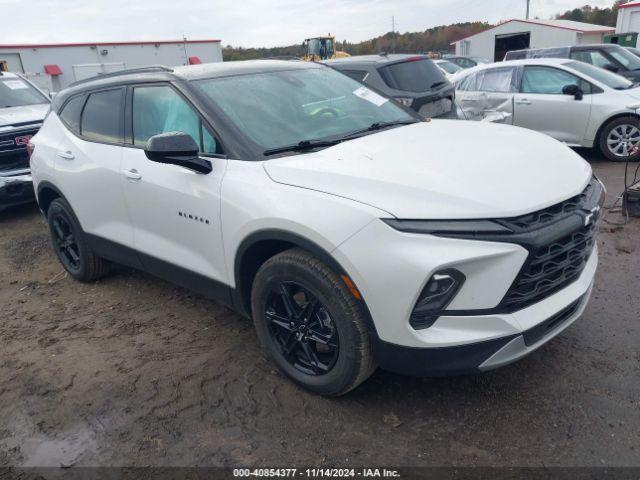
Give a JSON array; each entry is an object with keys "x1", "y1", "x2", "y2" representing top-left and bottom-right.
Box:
[{"x1": 513, "y1": 65, "x2": 592, "y2": 145}]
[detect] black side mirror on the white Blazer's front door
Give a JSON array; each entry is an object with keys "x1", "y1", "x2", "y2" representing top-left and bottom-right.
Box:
[{"x1": 144, "y1": 132, "x2": 213, "y2": 174}]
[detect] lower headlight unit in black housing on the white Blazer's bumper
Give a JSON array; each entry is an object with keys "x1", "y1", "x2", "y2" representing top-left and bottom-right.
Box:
[{"x1": 409, "y1": 268, "x2": 466, "y2": 330}]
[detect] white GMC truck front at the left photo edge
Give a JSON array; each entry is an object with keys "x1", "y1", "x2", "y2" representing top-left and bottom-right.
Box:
[{"x1": 0, "y1": 72, "x2": 49, "y2": 211}]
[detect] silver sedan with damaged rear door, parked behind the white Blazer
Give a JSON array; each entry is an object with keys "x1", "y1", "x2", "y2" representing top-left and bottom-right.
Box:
[{"x1": 455, "y1": 58, "x2": 640, "y2": 160}]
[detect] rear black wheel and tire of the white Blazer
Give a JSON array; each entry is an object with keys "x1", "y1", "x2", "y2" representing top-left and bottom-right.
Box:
[{"x1": 47, "y1": 198, "x2": 110, "y2": 282}]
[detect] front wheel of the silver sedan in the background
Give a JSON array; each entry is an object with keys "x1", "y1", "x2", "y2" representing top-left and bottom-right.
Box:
[{"x1": 598, "y1": 117, "x2": 640, "y2": 162}]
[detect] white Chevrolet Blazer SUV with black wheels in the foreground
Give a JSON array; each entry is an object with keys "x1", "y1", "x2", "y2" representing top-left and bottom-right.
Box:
[{"x1": 31, "y1": 61, "x2": 604, "y2": 395}]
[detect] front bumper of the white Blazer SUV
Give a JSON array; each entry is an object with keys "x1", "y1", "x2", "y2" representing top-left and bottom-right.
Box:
[{"x1": 333, "y1": 216, "x2": 598, "y2": 376}]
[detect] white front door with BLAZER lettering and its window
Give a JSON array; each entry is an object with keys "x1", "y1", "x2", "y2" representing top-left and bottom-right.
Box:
[{"x1": 121, "y1": 83, "x2": 227, "y2": 293}]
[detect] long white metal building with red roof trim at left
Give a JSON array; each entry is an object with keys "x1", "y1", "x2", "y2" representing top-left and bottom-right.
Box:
[{"x1": 0, "y1": 40, "x2": 222, "y2": 92}]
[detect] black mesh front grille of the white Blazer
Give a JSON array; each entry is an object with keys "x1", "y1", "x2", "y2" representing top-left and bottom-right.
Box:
[{"x1": 500, "y1": 178, "x2": 602, "y2": 312}]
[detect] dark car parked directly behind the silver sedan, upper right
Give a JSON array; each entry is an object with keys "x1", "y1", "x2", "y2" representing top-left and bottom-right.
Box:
[{"x1": 504, "y1": 43, "x2": 640, "y2": 82}]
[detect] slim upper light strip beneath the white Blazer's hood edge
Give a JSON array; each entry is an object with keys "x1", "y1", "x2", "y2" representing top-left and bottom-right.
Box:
[{"x1": 382, "y1": 218, "x2": 513, "y2": 235}]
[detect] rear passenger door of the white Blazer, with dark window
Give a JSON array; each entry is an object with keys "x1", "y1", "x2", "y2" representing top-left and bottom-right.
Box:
[{"x1": 55, "y1": 88, "x2": 133, "y2": 248}]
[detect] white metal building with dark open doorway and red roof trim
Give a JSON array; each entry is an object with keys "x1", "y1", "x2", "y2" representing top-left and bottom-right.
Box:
[{"x1": 451, "y1": 20, "x2": 615, "y2": 62}]
